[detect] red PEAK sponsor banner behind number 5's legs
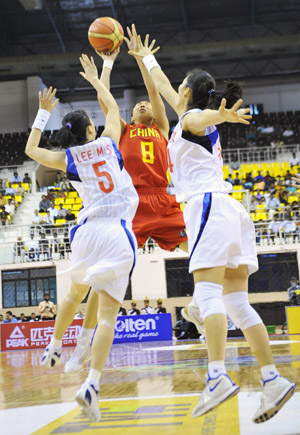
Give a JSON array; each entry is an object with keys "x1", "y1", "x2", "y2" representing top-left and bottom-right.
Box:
[{"x1": 1, "y1": 319, "x2": 83, "y2": 350}]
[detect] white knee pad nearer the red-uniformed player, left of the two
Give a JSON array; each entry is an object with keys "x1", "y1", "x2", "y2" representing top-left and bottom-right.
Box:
[{"x1": 194, "y1": 281, "x2": 226, "y2": 320}]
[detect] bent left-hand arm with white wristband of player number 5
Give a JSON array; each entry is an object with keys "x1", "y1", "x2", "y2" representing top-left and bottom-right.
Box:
[{"x1": 25, "y1": 87, "x2": 66, "y2": 172}]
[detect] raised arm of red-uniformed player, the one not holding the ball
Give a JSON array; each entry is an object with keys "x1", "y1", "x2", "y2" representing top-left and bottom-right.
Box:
[{"x1": 124, "y1": 24, "x2": 169, "y2": 140}]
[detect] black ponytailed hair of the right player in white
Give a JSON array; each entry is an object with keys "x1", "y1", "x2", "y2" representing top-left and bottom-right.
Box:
[{"x1": 186, "y1": 69, "x2": 242, "y2": 110}]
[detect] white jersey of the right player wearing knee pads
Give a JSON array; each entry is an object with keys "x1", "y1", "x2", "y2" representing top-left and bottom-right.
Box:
[{"x1": 168, "y1": 109, "x2": 232, "y2": 202}]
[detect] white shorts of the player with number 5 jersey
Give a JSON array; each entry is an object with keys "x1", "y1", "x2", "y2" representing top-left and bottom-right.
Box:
[{"x1": 70, "y1": 219, "x2": 137, "y2": 303}]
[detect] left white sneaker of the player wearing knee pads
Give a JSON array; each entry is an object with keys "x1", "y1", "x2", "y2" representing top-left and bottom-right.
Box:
[{"x1": 192, "y1": 374, "x2": 240, "y2": 417}]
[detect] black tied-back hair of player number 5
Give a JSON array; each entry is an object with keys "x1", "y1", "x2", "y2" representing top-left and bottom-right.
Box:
[{"x1": 50, "y1": 110, "x2": 91, "y2": 148}]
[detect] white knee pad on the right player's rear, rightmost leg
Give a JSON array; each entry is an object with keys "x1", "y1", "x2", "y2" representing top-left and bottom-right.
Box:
[{"x1": 223, "y1": 292, "x2": 262, "y2": 330}]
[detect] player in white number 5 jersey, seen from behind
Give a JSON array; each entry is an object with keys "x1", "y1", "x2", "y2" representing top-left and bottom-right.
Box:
[{"x1": 25, "y1": 55, "x2": 138, "y2": 421}]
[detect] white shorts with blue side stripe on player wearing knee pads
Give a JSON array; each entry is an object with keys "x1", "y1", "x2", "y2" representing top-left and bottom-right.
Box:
[{"x1": 183, "y1": 193, "x2": 258, "y2": 275}]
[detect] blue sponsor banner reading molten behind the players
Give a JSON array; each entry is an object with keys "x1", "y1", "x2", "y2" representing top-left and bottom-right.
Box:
[{"x1": 114, "y1": 313, "x2": 172, "y2": 343}]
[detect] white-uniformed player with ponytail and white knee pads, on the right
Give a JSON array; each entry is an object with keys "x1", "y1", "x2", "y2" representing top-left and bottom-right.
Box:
[{"x1": 129, "y1": 31, "x2": 296, "y2": 423}]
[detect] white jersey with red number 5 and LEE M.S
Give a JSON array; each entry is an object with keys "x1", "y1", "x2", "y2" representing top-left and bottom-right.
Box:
[{"x1": 66, "y1": 137, "x2": 139, "y2": 224}]
